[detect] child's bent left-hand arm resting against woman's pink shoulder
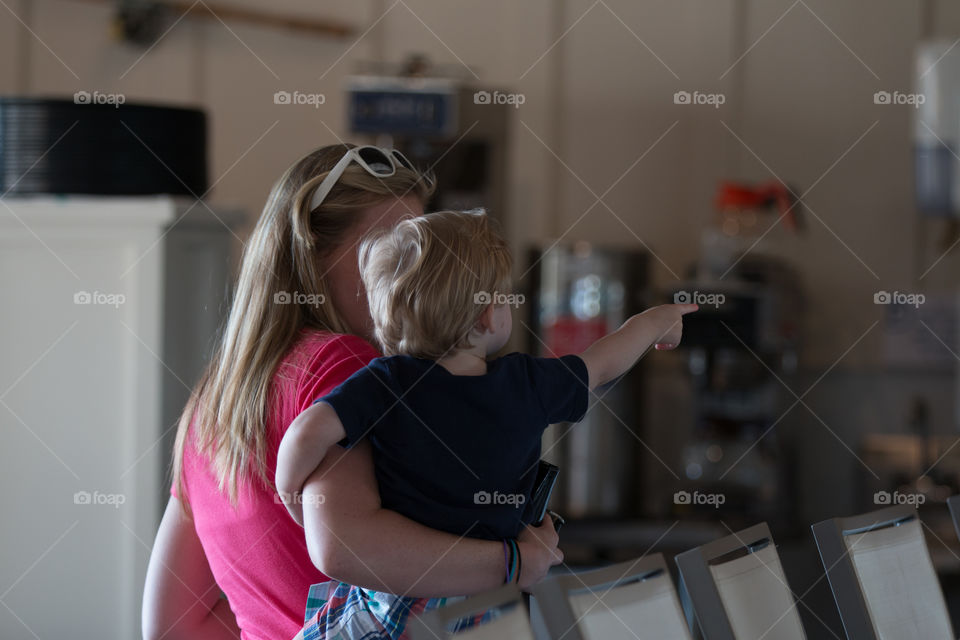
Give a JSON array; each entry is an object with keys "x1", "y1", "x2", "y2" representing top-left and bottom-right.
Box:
[{"x1": 276, "y1": 402, "x2": 347, "y2": 527}]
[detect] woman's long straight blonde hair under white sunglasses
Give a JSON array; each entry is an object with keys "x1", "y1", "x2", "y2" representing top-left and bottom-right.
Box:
[{"x1": 173, "y1": 144, "x2": 433, "y2": 508}]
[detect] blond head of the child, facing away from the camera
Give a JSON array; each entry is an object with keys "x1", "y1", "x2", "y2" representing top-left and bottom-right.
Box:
[{"x1": 360, "y1": 210, "x2": 511, "y2": 360}]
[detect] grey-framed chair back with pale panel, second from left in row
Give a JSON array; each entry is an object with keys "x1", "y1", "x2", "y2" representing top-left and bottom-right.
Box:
[{"x1": 533, "y1": 553, "x2": 690, "y2": 640}]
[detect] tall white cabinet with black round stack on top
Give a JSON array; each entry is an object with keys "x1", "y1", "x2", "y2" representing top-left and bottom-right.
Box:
[{"x1": 0, "y1": 196, "x2": 241, "y2": 640}]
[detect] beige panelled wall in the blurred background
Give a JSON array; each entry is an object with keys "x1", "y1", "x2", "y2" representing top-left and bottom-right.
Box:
[{"x1": 0, "y1": 0, "x2": 960, "y2": 367}]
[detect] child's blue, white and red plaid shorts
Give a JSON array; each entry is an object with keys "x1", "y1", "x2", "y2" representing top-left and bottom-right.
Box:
[{"x1": 297, "y1": 581, "x2": 490, "y2": 640}]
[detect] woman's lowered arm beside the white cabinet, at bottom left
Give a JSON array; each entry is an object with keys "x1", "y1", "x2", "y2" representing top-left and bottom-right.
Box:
[{"x1": 141, "y1": 497, "x2": 240, "y2": 640}]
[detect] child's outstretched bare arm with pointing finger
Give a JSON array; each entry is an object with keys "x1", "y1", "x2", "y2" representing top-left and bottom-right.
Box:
[{"x1": 580, "y1": 304, "x2": 699, "y2": 389}]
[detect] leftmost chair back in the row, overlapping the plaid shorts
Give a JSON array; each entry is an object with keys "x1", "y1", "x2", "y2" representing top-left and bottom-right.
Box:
[{"x1": 407, "y1": 584, "x2": 534, "y2": 640}]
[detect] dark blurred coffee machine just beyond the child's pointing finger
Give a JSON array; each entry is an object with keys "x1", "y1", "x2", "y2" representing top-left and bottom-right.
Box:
[{"x1": 665, "y1": 254, "x2": 802, "y2": 525}]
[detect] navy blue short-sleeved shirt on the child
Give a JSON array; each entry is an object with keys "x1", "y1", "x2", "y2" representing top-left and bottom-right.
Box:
[{"x1": 317, "y1": 353, "x2": 588, "y2": 540}]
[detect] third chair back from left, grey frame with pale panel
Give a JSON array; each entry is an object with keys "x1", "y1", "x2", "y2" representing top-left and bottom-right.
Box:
[{"x1": 676, "y1": 523, "x2": 806, "y2": 640}]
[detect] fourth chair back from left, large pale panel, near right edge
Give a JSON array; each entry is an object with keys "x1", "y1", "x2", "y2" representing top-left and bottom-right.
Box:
[{"x1": 812, "y1": 505, "x2": 956, "y2": 640}]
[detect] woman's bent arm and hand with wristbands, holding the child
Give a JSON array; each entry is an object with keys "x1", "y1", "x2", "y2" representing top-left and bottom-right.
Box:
[{"x1": 303, "y1": 442, "x2": 563, "y2": 598}]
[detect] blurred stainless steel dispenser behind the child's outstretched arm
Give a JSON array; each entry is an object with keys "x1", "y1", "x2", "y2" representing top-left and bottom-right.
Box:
[{"x1": 527, "y1": 242, "x2": 649, "y2": 519}]
